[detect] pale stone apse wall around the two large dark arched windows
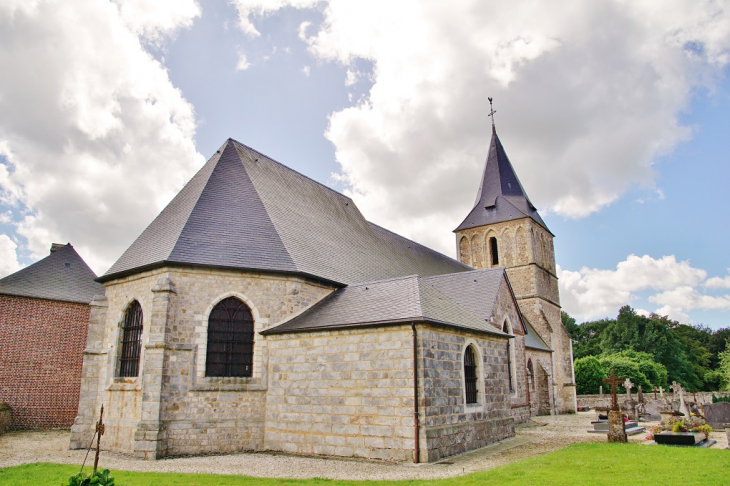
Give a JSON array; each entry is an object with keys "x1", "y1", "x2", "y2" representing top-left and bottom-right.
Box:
[{"x1": 71, "y1": 268, "x2": 333, "y2": 459}]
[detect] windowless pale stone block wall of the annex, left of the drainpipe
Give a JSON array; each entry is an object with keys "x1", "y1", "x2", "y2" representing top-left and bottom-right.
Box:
[{"x1": 265, "y1": 325, "x2": 414, "y2": 461}]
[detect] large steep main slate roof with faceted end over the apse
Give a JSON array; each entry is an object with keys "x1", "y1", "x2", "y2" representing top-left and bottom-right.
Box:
[{"x1": 98, "y1": 139, "x2": 471, "y2": 285}]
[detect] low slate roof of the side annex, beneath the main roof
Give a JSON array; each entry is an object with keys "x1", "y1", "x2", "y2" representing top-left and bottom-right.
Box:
[{"x1": 262, "y1": 269, "x2": 512, "y2": 338}]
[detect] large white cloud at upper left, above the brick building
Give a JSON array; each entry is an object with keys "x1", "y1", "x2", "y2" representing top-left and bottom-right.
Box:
[{"x1": 0, "y1": 0, "x2": 202, "y2": 272}]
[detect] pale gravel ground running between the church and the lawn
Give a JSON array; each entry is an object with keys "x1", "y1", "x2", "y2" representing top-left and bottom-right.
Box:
[{"x1": 0, "y1": 412, "x2": 728, "y2": 480}]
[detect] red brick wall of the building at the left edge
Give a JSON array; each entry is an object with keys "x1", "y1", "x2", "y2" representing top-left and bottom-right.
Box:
[{"x1": 0, "y1": 295, "x2": 89, "y2": 429}]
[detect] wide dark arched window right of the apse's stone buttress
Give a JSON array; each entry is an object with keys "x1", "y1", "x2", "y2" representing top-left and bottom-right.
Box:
[{"x1": 205, "y1": 297, "x2": 253, "y2": 377}]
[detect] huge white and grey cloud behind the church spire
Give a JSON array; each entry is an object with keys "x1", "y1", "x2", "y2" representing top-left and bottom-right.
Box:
[{"x1": 234, "y1": 0, "x2": 730, "y2": 254}]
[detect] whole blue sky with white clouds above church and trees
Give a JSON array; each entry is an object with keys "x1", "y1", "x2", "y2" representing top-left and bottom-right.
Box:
[{"x1": 0, "y1": 0, "x2": 730, "y2": 329}]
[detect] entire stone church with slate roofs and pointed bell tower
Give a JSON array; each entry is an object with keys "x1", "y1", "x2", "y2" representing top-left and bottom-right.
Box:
[{"x1": 71, "y1": 125, "x2": 575, "y2": 462}]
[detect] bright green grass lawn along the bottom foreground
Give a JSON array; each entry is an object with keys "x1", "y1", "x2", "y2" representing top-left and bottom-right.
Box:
[{"x1": 0, "y1": 443, "x2": 730, "y2": 486}]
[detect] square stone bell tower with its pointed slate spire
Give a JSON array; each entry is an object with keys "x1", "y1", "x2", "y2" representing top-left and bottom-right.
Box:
[{"x1": 454, "y1": 112, "x2": 576, "y2": 413}]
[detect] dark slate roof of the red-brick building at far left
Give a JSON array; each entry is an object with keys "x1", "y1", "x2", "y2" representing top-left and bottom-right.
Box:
[{"x1": 0, "y1": 243, "x2": 104, "y2": 304}]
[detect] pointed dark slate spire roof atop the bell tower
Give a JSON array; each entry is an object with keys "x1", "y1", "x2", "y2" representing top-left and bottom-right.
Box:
[{"x1": 454, "y1": 127, "x2": 552, "y2": 234}]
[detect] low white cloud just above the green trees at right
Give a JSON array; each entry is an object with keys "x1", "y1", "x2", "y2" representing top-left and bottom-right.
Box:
[{"x1": 557, "y1": 255, "x2": 730, "y2": 322}]
